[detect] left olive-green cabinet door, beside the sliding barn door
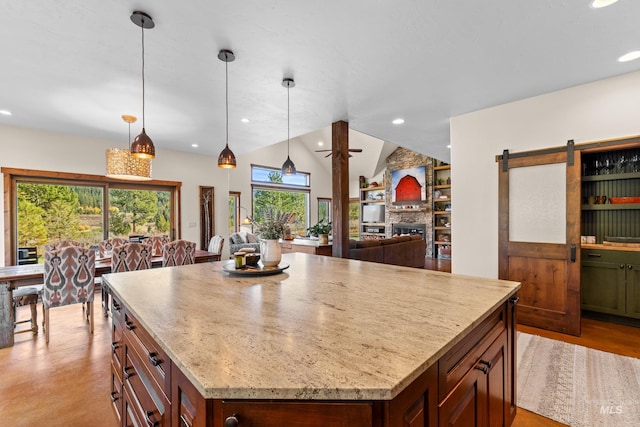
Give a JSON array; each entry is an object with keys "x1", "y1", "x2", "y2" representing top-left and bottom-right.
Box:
[{"x1": 580, "y1": 261, "x2": 624, "y2": 316}]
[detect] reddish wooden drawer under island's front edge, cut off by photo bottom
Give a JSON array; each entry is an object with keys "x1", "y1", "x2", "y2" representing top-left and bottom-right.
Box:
[{"x1": 220, "y1": 400, "x2": 373, "y2": 427}]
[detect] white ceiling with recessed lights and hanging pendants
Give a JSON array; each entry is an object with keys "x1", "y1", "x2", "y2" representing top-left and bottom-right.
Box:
[{"x1": 0, "y1": 0, "x2": 640, "y2": 166}]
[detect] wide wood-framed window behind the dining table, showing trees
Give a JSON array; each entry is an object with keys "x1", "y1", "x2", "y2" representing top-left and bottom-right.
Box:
[{"x1": 2, "y1": 168, "x2": 180, "y2": 265}]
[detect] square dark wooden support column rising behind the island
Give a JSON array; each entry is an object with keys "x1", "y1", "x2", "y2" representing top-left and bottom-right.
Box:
[{"x1": 331, "y1": 121, "x2": 349, "y2": 258}]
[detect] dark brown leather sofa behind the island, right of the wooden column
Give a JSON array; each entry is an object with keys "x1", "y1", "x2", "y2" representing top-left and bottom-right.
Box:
[{"x1": 349, "y1": 235, "x2": 427, "y2": 268}]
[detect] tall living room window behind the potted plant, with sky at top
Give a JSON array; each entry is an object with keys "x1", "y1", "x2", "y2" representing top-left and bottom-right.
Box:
[{"x1": 251, "y1": 165, "x2": 311, "y2": 235}]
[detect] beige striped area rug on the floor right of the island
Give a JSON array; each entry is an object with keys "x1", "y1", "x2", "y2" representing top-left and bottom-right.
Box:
[{"x1": 517, "y1": 332, "x2": 640, "y2": 427}]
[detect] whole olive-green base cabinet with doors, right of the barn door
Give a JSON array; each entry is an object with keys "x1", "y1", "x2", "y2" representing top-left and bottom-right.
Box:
[{"x1": 580, "y1": 249, "x2": 640, "y2": 318}]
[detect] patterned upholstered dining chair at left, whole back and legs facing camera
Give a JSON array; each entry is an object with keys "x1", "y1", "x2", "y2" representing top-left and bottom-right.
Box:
[{"x1": 42, "y1": 246, "x2": 96, "y2": 343}]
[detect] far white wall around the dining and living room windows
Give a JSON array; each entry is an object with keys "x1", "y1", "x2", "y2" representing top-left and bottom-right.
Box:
[{"x1": 0, "y1": 125, "x2": 331, "y2": 265}]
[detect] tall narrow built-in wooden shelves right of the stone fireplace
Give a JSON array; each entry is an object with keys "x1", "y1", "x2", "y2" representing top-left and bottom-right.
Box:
[{"x1": 433, "y1": 160, "x2": 452, "y2": 258}]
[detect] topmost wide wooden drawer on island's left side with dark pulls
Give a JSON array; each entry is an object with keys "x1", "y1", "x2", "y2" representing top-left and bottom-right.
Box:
[{"x1": 124, "y1": 312, "x2": 171, "y2": 396}]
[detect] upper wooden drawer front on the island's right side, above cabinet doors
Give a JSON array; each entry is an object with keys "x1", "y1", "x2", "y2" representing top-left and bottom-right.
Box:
[{"x1": 438, "y1": 305, "x2": 507, "y2": 401}]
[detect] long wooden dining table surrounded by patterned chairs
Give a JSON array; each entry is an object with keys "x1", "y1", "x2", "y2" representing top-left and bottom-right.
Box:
[{"x1": 0, "y1": 249, "x2": 220, "y2": 348}]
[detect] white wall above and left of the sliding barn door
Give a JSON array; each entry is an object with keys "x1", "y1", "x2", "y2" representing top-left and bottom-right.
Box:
[{"x1": 451, "y1": 73, "x2": 640, "y2": 278}]
